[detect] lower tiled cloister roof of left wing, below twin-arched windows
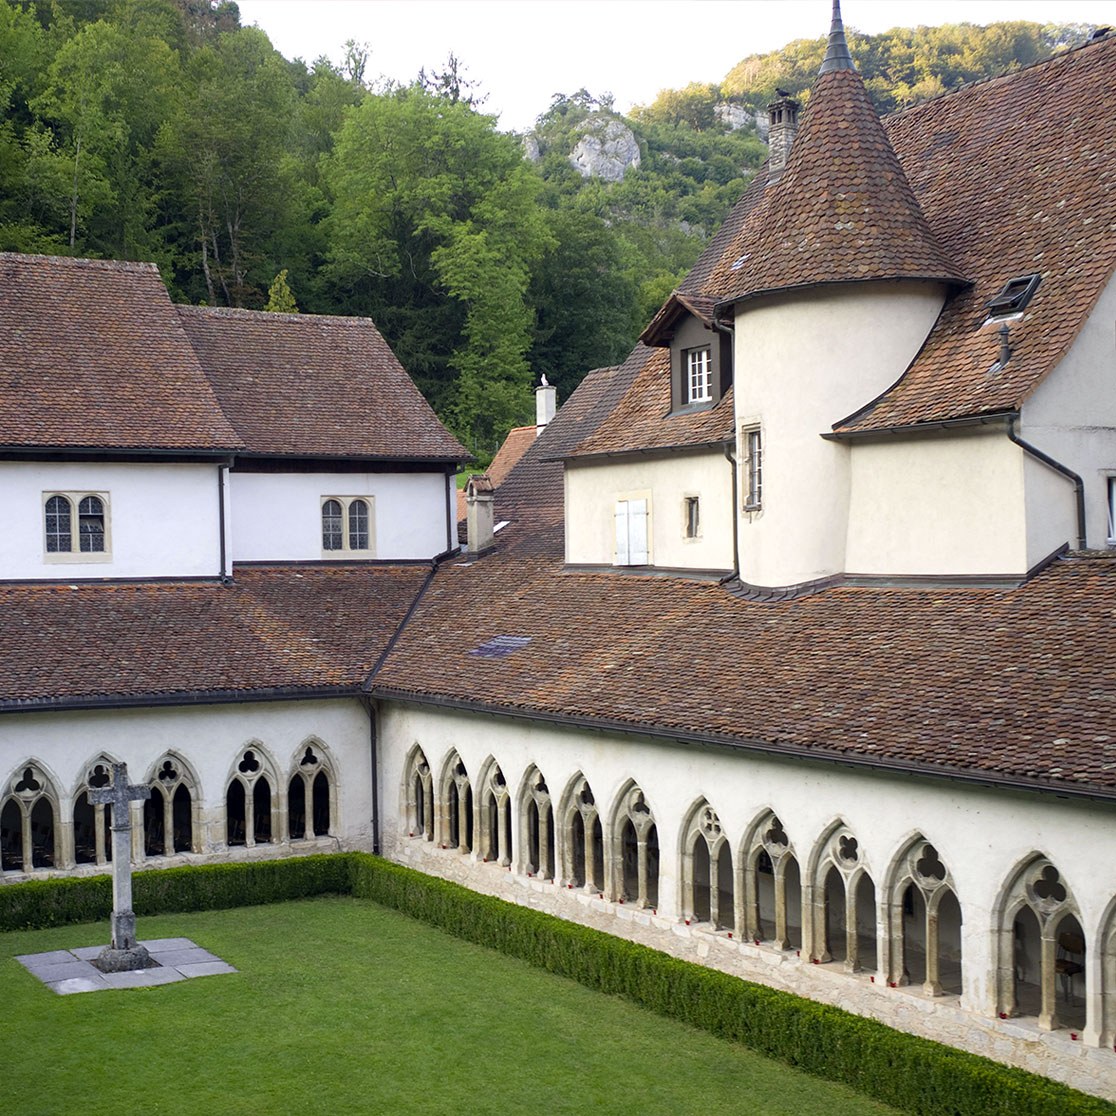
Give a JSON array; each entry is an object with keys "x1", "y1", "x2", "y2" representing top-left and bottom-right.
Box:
[{"x1": 0, "y1": 564, "x2": 429, "y2": 709}]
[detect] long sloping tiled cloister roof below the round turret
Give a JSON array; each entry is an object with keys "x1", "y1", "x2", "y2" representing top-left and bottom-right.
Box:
[{"x1": 376, "y1": 546, "x2": 1116, "y2": 792}]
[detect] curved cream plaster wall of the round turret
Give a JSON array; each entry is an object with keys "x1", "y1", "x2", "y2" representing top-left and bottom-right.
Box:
[{"x1": 733, "y1": 282, "x2": 943, "y2": 586}]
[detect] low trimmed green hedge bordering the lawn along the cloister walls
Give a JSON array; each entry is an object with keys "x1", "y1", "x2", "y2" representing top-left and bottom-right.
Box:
[{"x1": 0, "y1": 853, "x2": 1116, "y2": 1116}]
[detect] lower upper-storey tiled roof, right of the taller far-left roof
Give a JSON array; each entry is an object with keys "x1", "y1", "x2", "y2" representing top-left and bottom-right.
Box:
[{"x1": 177, "y1": 306, "x2": 469, "y2": 461}]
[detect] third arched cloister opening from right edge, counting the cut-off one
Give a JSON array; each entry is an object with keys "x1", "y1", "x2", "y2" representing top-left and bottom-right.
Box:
[{"x1": 888, "y1": 837, "x2": 961, "y2": 995}]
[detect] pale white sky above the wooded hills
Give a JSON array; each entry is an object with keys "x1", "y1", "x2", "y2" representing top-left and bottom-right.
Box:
[{"x1": 239, "y1": 0, "x2": 1116, "y2": 132}]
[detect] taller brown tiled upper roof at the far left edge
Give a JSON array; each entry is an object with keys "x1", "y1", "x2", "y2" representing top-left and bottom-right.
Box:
[{"x1": 0, "y1": 252, "x2": 240, "y2": 452}]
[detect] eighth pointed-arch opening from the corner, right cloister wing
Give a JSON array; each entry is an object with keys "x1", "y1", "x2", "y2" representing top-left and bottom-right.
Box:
[{"x1": 743, "y1": 810, "x2": 802, "y2": 950}]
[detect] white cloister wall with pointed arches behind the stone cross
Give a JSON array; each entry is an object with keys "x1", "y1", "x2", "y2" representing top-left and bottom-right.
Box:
[{"x1": 0, "y1": 699, "x2": 372, "y2": 861}]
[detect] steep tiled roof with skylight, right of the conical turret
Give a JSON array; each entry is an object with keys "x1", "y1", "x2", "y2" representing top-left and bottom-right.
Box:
[{"x1": 835, "y1": 37, "x2": 1116, "y2": 432}]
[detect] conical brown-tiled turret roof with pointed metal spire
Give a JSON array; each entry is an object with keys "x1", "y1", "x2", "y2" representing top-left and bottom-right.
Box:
[{"x1": 705, "y1": 3, "x2": 965, "y2": 301}]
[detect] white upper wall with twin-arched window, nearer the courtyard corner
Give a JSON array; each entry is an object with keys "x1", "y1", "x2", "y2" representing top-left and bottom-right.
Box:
[{"x1": 230, "y1": 471, "x2": 446, "y2": 561}]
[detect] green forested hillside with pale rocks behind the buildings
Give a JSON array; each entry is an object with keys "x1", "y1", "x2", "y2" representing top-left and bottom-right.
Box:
[{"x1": 0, "y1": 0, "x2": 1088, "y2": 454}]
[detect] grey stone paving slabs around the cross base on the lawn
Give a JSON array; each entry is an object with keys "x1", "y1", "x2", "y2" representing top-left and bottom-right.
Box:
[{"x1": 16, "y1": 937, "x2": 237, "y2": 995}]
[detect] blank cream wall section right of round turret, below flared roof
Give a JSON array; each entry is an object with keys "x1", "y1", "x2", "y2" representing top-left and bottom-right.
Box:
[{"x1": 847, "y1": 426, "x2": 1026, "y2": 576}]
